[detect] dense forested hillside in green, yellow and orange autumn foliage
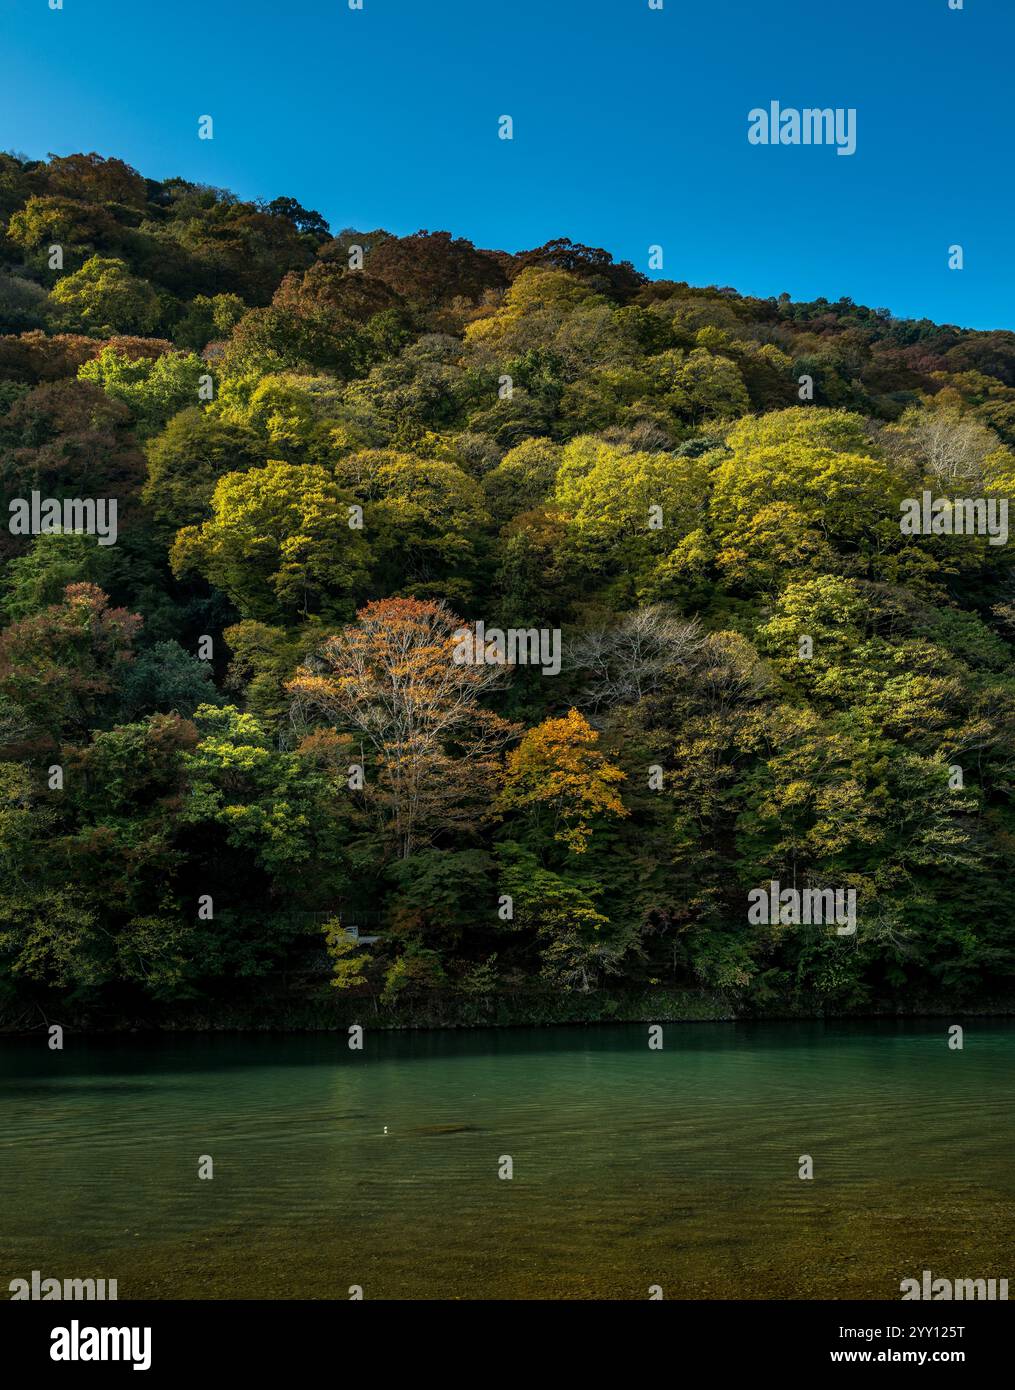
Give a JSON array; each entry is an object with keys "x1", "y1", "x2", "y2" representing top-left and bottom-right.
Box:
[{"x1": 0, "y1": 154, "x2": 1015, "y2": 1022}]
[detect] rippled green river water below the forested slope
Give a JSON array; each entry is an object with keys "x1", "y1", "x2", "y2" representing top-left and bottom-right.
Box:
[{"x1": 0, "y1": 1019, "x2": 1015, "y2": 1300}]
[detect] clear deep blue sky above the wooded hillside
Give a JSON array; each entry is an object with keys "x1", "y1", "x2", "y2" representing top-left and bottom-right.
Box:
[{"x1": 0, "y1": 0, "x2": 1015, "y2": 328}]
